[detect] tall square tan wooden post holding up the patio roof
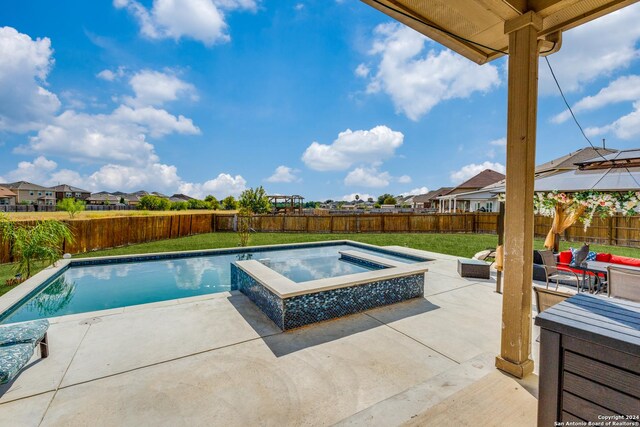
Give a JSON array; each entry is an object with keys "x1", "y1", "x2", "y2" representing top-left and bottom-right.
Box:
[{"x1": 496, "y1": 11, "x2": 542, "y2": 378}]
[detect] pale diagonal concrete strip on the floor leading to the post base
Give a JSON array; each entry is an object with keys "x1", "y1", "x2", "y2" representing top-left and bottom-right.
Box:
[{"x1": 335, "y1": 353, "x2": 496, "y2": 426}]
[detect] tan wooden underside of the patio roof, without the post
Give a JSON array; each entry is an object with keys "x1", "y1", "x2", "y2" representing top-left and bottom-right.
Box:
[{"x1": 361, "y1": 0, "x2": 637, "y2": 64}]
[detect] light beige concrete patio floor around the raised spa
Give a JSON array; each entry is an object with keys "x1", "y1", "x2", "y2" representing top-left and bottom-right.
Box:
[{"x1": 0, "y1": 248, "x2": 538, "y2": 426}]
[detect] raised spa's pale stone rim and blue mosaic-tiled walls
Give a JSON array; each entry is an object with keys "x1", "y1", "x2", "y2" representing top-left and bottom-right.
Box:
[{"x1": 231, "y1": 250, "x2": 428, "y2": 331}]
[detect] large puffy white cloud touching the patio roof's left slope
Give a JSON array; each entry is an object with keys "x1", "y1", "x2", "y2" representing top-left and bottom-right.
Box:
[{"x1": 356, "y1": 23, "x2": 500, "y2": 120}]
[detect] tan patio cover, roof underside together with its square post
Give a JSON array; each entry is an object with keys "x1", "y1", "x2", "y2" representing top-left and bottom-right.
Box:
[{"x1": 361, "y1": 0, "x2": 637, "y2": 378}]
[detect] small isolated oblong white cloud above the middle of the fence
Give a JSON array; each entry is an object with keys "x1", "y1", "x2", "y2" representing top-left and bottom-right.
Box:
[{"x1": 302, "y1": 126, "x2": 404, "y2": 171}]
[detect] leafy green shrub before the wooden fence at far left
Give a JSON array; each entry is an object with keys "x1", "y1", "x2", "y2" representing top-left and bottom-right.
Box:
[{"x1": 0, "y1": 214, "x2": 73, "y2": 279}]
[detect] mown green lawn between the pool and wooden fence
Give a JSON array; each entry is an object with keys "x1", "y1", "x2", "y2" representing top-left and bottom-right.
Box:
[{"x1": 0, "y1": 233, "x2": 640, "y2": 295}]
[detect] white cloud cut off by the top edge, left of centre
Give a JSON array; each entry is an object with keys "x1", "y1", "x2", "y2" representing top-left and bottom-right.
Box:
[{"x1": 113, "y1": 0, "x2": 257, "y2": 46}]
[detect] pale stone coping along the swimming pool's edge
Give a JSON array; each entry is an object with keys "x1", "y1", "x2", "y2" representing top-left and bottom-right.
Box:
[{"x1": 0, "y1": 239, "x2": 433, "y2": 322}]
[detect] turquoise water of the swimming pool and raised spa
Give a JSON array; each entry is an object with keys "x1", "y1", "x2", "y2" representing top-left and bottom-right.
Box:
[{"x1": 0, "y1": 245, "x2": 418, "y2": 323}]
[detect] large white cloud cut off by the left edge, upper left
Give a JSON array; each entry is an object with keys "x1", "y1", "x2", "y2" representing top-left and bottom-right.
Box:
[{"x1": 0, "y1": 27, "x2": 60, "y2": 133}]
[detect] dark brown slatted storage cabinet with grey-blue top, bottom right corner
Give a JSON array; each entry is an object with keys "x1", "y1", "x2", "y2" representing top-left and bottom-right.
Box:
[{"x1": 535, "y1": 294, "x2": 640, "y2": 427}]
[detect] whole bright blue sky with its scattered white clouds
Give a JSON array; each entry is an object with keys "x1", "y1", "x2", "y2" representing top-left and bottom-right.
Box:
[{"x1": 0, "y1": 0, "x2": 640, "y2": 200}]
